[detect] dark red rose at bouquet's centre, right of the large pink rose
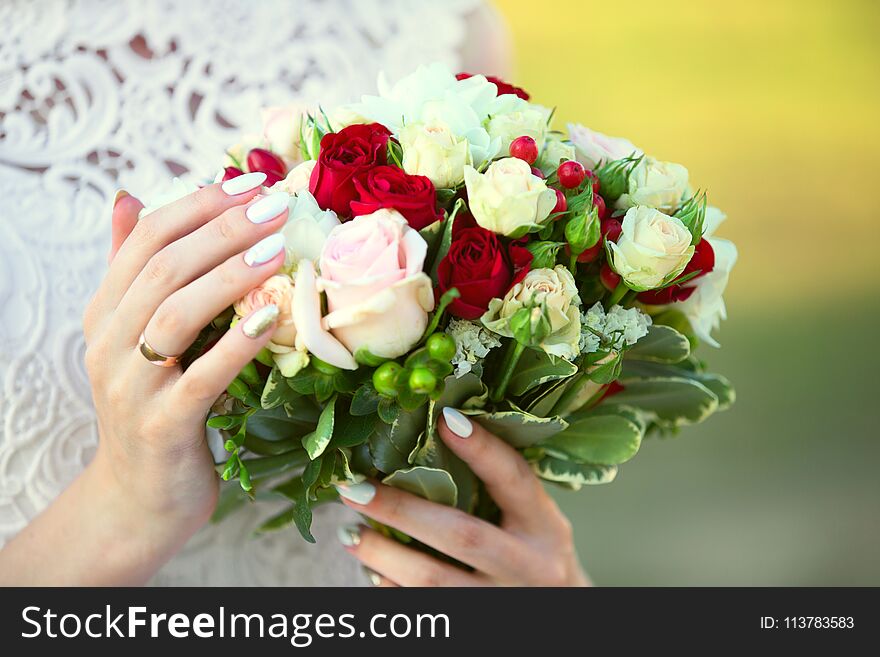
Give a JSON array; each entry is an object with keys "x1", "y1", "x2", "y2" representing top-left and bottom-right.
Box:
[{"x1": 437, "y1": 220, "x2": 532, "y2": 319}]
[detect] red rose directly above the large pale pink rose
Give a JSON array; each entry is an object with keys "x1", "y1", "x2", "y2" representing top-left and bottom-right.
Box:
[{"x1": 351, "y1": 165, "x2": 443, "y2": 230}]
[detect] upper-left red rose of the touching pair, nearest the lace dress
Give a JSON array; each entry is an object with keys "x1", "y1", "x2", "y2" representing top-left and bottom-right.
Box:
[{"x1": 309, "y1": 123, "x2": 391, "y2": 218}]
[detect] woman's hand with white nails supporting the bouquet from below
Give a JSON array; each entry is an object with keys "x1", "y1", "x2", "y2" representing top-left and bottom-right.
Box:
[{"x1": 340, "y1": 409, "x2": 589, "y2": 586}]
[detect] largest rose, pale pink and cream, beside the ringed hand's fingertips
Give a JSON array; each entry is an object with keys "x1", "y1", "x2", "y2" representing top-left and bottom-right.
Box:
[{"x1": 295, "y1": 209, "x2": 434, "y2": 369}]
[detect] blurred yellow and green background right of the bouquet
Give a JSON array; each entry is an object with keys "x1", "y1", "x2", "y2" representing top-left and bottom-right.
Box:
[{"x1": 496, "y1": 0, "x2": 880, "y2": 585}]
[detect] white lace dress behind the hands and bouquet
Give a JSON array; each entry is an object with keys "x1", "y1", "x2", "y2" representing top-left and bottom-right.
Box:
[{"x1": 0, "y1": 0, "x2": 482, "y2": 585}]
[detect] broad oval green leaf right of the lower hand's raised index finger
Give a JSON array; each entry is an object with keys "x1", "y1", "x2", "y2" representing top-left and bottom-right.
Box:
[{"x1": 541, "y1": 411, "x2": 645, "y2": 465}]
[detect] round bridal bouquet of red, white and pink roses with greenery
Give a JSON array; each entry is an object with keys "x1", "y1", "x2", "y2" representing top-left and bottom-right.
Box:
[{"x1": 174, "y1": 66, "x2": 736, "y2": 541}]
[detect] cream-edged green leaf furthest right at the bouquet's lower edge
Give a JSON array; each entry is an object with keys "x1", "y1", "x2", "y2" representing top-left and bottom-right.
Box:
[{"x1": 605, "y1": 376, "x2": 718, "y2": 428}]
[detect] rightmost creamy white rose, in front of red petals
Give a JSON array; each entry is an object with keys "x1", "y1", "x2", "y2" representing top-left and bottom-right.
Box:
[{"x1": 608, "y1": 205, "x2": 694, "y2": 292}]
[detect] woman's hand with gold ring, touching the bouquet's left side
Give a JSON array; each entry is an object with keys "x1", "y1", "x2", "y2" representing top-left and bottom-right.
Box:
[{"x1": 83, "y1": 174, "x2": 287, "y2": 552}]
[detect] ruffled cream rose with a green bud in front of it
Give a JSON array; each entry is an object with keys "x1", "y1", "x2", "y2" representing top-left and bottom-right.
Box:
[{"x1": 481, "y1": 265, "x2": 581, "y2": 360}]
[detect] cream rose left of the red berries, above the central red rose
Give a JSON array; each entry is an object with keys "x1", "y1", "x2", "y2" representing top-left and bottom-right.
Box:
[{"x1": 464, "y1": 157, "x2": 556, "y2": 238}]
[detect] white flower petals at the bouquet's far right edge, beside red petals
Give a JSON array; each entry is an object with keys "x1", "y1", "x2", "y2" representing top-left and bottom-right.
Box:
[{"x1": 675, "y1": 237, "x2": 737, "y2": 347}]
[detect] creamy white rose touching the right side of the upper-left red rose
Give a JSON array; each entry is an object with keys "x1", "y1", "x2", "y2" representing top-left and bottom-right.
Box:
[{"x1": 400, "y1": 123, "x2": 473, "y2": 189}]
